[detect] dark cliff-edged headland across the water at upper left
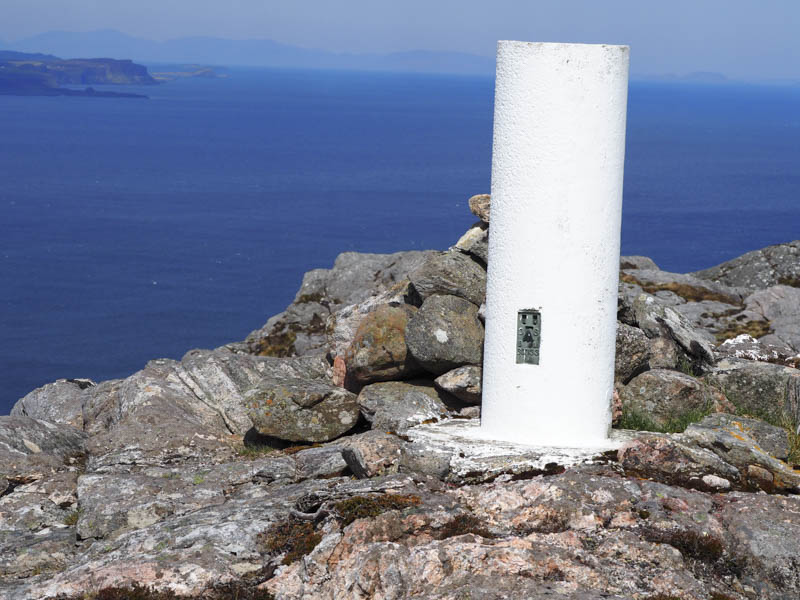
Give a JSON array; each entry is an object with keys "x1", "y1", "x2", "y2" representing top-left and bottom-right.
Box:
[{"x1": 0, "y1": 51, "x2": 158, "y2": 98}]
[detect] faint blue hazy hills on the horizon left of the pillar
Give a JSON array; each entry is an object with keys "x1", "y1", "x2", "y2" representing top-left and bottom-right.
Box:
[{"x1": 4, "y1": 30, "x2": 494, "y2": 75}]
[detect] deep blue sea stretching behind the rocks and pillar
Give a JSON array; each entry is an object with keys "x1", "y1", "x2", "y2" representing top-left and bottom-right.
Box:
[{"x1": 0, "y1": 70, "x2": 800, "y2": 414}]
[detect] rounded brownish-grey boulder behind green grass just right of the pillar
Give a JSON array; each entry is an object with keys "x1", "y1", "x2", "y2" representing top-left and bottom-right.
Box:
[{"x1": 619, "y1": 369, "x2": 734, "y2": 427}]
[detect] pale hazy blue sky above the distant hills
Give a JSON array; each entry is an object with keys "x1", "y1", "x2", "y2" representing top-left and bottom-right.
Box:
[{"x1": 0, "y1": 0, "x2": 800, "y2": 79}]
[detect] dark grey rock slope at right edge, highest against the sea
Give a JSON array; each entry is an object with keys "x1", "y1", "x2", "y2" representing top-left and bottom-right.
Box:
[{"x1": 694, "y1": 240, "x2": 800, "y2": 290}]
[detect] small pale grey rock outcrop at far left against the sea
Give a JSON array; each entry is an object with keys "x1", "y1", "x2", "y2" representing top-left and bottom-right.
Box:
[{"x1": 11, "y1": 379, "x2": 95, "y2": 429}]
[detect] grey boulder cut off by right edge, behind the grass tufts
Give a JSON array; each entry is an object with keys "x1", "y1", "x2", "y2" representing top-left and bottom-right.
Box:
[{"x1": 702, "y1": 358, "x2": 800, "y2": 427}]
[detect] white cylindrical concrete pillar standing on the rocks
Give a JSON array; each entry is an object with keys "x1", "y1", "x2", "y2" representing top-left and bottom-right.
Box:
[{"x1": 481, "y1": 41, "x2": 629, "y2": 447}]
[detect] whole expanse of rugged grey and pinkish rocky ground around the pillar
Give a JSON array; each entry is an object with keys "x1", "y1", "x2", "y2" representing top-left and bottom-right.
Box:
[{"x1": 0, "y1": 196, "x2": 800, "y2": 600}]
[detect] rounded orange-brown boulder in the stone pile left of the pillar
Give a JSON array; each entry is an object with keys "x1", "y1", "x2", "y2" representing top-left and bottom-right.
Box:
[{"x1": 344, "y1": 304, "x2": 423, "y2": 387}]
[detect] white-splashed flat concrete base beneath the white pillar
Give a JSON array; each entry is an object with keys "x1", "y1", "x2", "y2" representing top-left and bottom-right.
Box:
[{"x1": 406, "y1": 419, "x2": 637, "y2": 483}]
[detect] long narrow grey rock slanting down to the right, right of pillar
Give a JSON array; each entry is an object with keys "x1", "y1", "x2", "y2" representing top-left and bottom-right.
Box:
[{"x1": 632, "y1": 294, "x2": 714, "y2": 364}]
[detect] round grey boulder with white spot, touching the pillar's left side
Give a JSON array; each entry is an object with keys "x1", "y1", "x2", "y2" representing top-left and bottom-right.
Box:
[{"x1": 406, "y1": 296, "x2": 484, "y2": 375}]
